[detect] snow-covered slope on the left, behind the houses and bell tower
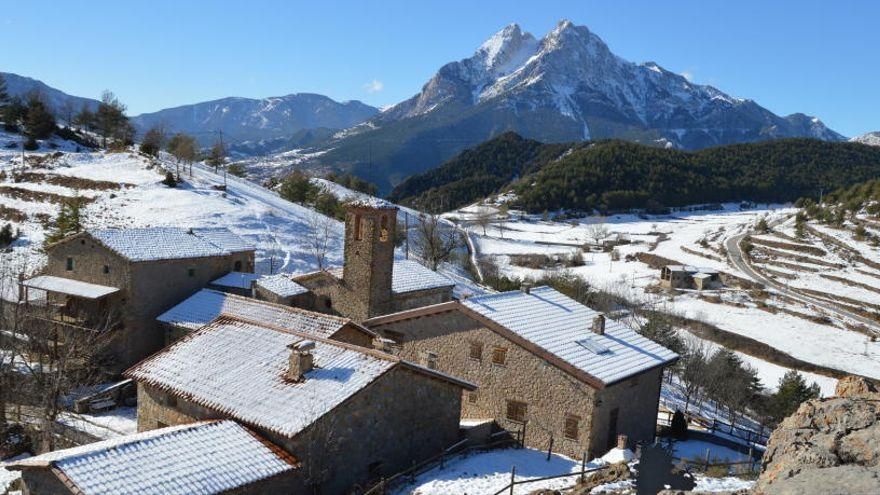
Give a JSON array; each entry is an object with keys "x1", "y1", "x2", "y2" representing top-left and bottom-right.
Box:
[{"x1": 0, "y1": 133, "x2": 342, "y2": 288}]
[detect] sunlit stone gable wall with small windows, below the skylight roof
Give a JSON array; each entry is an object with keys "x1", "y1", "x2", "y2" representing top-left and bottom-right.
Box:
[{"x1": 372, "y1": 311, "x2": 600, "y2": 458}]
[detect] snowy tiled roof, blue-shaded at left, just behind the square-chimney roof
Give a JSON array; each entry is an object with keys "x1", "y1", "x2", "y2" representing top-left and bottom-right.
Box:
[{"x1": 156, "y1": 289, "x2": 349, "y2": 338}]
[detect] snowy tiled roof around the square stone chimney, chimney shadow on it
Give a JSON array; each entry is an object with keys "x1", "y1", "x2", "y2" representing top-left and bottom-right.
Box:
[{"x1": 125, "y1": 318, "x2": 397, "y2": 437}]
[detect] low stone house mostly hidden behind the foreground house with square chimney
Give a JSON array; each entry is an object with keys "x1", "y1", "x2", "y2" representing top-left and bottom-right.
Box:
[{"x1": 156, "y1": 289, "x2": 377, "y2": 347}]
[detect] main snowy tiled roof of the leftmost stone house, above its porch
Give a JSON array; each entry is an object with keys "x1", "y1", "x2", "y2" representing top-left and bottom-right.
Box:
[{"x1": 89, "y1": 227, "x2": 253, "y2": 261}]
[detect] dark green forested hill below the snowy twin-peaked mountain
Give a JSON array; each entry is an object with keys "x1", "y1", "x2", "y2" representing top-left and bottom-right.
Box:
[{"x1": 391, "y1": 134, "x2": 880, "y2": 212}]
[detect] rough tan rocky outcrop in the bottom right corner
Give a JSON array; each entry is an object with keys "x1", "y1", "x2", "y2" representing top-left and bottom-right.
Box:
[{"x1": 755, "y1": 376, "x2": 880, "y2": 495}]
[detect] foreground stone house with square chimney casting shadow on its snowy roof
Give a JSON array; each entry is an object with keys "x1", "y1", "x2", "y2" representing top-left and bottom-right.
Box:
[{"x1": 125, "y1": 315, "x2": 475, "y2": 494}]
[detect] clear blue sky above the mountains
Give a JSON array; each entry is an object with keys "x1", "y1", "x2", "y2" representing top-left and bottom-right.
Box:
[{"x1": 0, "y1": 0, "x2": 880, "y2": 136}]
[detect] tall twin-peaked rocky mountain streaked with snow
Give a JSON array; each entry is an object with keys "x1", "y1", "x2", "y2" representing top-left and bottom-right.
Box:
[{"x1": 308, "y1": 20, "x2": 844, "y2": 190}]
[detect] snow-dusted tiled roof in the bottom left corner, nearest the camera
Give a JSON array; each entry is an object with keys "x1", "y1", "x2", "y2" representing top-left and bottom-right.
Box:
[{"x1": 13, "y1": 421, "x2": 296, "y2": 495}]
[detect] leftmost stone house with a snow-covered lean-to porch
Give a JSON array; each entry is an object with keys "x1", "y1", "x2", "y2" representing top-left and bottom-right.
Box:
[{"x1": 21, "y1": 227, "x2": 254, "y2": 370}]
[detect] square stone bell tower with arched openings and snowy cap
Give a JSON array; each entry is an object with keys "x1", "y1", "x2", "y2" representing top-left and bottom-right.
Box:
[{"x1": 342, "y1": 200, "x2": 397, "y2": 319}]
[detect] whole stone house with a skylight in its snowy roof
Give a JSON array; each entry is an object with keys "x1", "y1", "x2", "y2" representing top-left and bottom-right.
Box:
[{"x1": 365, "y1": 287, "x2": 678, "y2": 458}]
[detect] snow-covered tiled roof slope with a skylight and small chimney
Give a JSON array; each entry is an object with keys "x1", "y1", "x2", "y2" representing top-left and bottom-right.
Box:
[{"x1": 461, "y1": 287, "x2": 678, "y2": 385}]
